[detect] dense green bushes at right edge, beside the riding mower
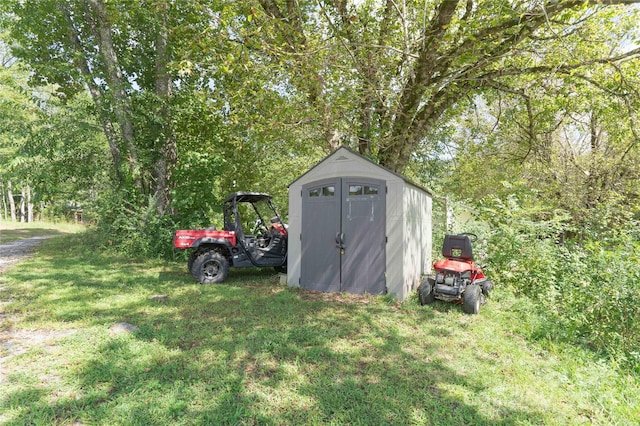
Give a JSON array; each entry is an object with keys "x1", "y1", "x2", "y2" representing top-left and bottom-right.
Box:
[{"x1": 480, "y1": 197, "x2": 640, "y2": 372}]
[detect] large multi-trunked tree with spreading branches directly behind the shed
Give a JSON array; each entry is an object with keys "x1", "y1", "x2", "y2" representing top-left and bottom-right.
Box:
[{"x1": 247, "y1": 0, "x2": 640, "y2": 171}]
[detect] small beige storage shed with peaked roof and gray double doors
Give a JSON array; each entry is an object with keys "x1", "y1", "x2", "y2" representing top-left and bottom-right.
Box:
[{"x1": 287, "y1": 147, "x2": 432, "y2": 300}]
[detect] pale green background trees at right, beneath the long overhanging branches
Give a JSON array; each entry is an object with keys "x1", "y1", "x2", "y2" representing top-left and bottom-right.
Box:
[{"x1": 445, "y1": 51, "x2": 640, "y2": 229}]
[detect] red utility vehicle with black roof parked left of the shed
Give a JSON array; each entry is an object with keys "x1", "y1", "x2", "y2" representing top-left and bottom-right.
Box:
[{"x1": 173, "y1": 192, "x2": 287, "y2": 284}]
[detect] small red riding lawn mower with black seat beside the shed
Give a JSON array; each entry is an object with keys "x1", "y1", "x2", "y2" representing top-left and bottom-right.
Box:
[{"x1": 418, "y1": 232, "x2": 493, "y2": 314}]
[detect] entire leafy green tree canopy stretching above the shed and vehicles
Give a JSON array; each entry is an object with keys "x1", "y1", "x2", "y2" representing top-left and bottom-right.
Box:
[{"x1": 0, "y1": 0, "x2": 640, "y2": 230}]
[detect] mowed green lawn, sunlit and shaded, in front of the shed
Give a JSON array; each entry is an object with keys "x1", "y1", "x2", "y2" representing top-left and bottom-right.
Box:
[{"x1": 0, "y1": 231, "x2": 640, "y2": 425}]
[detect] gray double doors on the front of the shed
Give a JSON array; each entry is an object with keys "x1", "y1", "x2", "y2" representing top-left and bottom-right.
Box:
[{"x1": 300, "y1": 177, "x2": 386, "y2": 294}]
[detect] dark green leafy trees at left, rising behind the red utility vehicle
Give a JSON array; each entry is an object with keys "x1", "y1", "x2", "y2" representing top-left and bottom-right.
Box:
[{"x1": 0, "y1": 0, "x2": 324, "y2": 215}]
